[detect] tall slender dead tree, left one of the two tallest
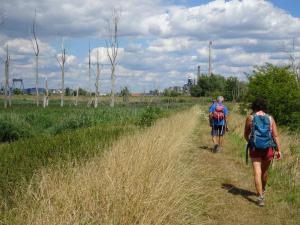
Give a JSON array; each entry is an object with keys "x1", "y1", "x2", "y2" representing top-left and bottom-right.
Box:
[{"x1": 31, "y1": 10, "x2": 40, "y2": 106}]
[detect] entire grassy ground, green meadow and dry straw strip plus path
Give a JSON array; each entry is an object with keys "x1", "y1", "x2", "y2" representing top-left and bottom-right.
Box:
[{"x1": 0, "y1": 97, "x2": 300, "y2": 225}]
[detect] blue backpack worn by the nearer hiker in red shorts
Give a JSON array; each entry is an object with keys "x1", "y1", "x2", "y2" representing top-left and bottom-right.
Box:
[{"x1": 249, "y1": 114, "x2": 276, "y2": 150}]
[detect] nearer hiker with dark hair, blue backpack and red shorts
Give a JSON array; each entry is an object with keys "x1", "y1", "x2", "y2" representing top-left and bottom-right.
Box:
[{"x1": 244, "y1": 98, "x2": 281, "y2": 206}]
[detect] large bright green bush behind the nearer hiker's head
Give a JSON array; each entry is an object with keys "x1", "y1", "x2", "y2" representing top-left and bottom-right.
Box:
[{"x1": 248, "y1": 64, "x2": 300, "y2": 127}]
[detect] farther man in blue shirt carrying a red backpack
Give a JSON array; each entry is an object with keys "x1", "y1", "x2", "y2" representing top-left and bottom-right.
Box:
[{"x1": 209, "y1": 96, "x2": 228, "y2": 152}]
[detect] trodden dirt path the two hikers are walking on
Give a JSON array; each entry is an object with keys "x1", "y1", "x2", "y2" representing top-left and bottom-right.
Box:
[{"x1": 188, "y1": 112, "x2": 297, "y2": 225}]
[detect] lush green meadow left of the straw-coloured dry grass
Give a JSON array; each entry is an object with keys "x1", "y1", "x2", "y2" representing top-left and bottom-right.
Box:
[{"x1": 0, "y1": 96, "x2": 199, "y2": 212}]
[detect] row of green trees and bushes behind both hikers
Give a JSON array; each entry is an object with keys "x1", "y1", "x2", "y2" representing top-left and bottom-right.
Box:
[{"x1": 190, "y1": 63, "x2": 300, "y2": 129}]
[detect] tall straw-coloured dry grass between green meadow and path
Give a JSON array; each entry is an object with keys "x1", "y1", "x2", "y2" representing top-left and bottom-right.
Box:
[{"x1": 8, "y1": 108, "x2": 201, "y2": 225}]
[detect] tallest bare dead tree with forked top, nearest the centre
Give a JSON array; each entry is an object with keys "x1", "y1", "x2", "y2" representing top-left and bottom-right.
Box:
[{"x1": 106, "y1": 8, "x2": 120, "y2": 107}]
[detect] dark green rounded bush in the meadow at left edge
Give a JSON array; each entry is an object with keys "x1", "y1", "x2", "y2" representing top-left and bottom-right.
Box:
[{"x1": 0, "y1": 116, "x2": 32, "y2": 142}]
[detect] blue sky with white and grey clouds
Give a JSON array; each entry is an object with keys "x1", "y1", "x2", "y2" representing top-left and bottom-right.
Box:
[{"x1": 0, "y1": 0, "x2": 300, "y2": 92}]
